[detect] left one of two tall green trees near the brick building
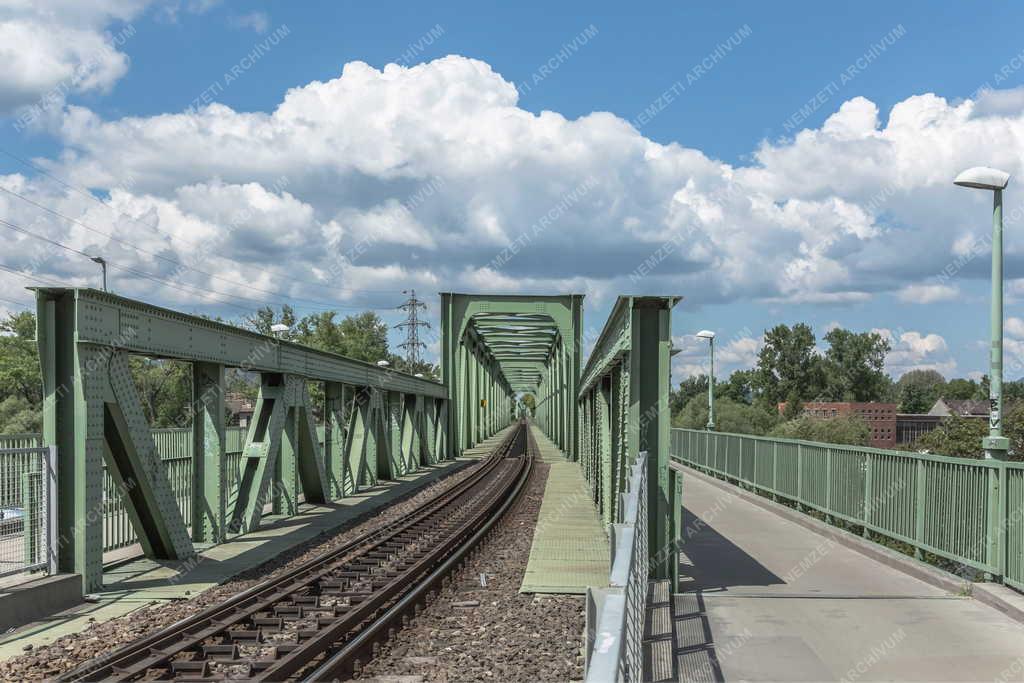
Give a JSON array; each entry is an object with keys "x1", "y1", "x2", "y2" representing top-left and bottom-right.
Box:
[{"x1": 753, "y1": 323, "x2": 823, "y2": 405}]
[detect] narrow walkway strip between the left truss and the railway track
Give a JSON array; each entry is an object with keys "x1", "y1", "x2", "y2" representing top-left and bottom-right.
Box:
[{"x1": 0, "y1": 454, "x2": 483, "y2": 659}]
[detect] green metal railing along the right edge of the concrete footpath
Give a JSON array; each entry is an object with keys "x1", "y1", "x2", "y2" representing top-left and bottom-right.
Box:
[{"x1": 672, "y1": 429, "x2": 1024, "y2": 590}]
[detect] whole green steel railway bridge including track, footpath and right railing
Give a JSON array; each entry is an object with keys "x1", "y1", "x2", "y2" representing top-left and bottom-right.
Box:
[{"x1": 0, "y1": 288, "x2": 1024, "y2": 681}]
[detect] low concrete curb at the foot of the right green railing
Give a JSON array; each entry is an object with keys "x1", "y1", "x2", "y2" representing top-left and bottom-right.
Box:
[{"x1": 672, "y1": 463, "x2": 1024, "y2": 623}]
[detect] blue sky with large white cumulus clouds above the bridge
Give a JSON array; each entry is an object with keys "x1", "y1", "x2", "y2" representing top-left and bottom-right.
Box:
[{"x1": 0, "y1": 0, "x2": 1024, "y2": 379}]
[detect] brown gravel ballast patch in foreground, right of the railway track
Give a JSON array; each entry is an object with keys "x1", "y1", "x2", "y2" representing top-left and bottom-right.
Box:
[{"x1": 357, "y1": 461, "x2": 584, "y2": 683}]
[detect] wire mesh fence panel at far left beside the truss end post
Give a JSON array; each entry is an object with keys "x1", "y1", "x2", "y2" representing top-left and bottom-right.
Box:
[{"x1": 0, "y1": 446, "x2": 56, "y2": 577}]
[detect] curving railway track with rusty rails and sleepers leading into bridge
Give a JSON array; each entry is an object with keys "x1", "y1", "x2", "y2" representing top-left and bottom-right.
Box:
[{"x1": 57, "y1": 423, "x2": 537, "y2": 681}]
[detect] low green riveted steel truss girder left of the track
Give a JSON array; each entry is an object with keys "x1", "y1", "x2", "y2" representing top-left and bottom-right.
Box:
[{"x1": 34, "y1": 288, "x2": 449, "y2": 591}]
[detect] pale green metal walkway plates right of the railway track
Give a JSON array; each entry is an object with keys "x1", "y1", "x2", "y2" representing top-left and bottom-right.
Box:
[{"x1": 519, "y1": 426, "x2": 610, "y2": 594}]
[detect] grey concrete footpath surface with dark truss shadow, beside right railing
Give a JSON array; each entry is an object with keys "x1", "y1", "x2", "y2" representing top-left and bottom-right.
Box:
[{"x1": 674, "y1": 469, "x2": 1024, "y2": 681}]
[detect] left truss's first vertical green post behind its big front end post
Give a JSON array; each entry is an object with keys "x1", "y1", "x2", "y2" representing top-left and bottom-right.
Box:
[{"x1": 191, "y1": 361, "x2": 227, "y2": 543}]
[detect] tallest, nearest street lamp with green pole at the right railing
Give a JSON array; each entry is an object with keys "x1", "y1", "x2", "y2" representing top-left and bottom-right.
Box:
[{"x1": 953, "y1": 166, "x2": 1010, "y2": 460}]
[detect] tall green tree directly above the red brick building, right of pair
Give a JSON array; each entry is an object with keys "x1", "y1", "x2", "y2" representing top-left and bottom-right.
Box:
[{"x1": 823, "y1": 328, "x2": 892, "y2": 401}]
